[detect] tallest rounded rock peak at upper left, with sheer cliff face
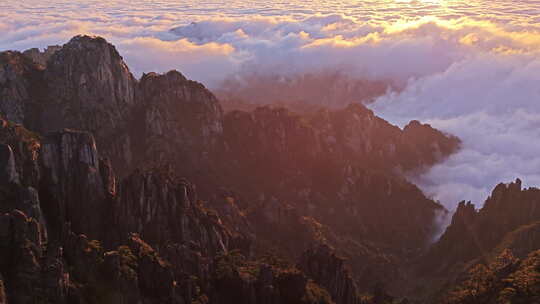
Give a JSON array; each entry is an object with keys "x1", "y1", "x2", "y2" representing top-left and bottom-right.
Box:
[{"x1": 42, "y1": 36, "x2": 136, "y2": 170}]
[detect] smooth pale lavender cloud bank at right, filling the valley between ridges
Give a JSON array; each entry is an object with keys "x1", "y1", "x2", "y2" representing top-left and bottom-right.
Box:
[{"x1": 373, "y1": 55, "x2": 540, "y2": 209}]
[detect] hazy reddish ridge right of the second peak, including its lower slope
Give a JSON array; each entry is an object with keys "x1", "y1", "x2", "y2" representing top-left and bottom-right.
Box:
[{"x1": 221, "y1": 105, "x2": 459, "y2": 258}]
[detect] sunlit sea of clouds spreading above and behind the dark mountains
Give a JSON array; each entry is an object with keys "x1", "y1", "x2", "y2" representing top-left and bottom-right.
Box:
[{"x1": 0, "y1": 0, "x2": 540, "y2": 210}]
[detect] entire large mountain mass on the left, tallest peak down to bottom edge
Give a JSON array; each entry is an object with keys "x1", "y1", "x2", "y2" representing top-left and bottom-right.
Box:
[{"x1": 0, "y1": 36, "x2": 459, "y2": 304}]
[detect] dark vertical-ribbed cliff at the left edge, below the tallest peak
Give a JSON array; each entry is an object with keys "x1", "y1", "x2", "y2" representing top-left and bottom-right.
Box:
[{"x1": 0, "y1": 122, "x2": 114, "y2": 245}]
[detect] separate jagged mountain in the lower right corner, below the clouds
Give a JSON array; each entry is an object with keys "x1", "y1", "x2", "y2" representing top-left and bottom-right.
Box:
[{"x1": 400, "y1": 179, "x2": 540, "y2": 304}]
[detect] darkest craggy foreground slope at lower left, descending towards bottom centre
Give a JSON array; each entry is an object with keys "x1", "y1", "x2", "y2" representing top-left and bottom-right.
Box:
[{"x1": 0, "y1": 121, "x2": 342, "y2": 304}]
